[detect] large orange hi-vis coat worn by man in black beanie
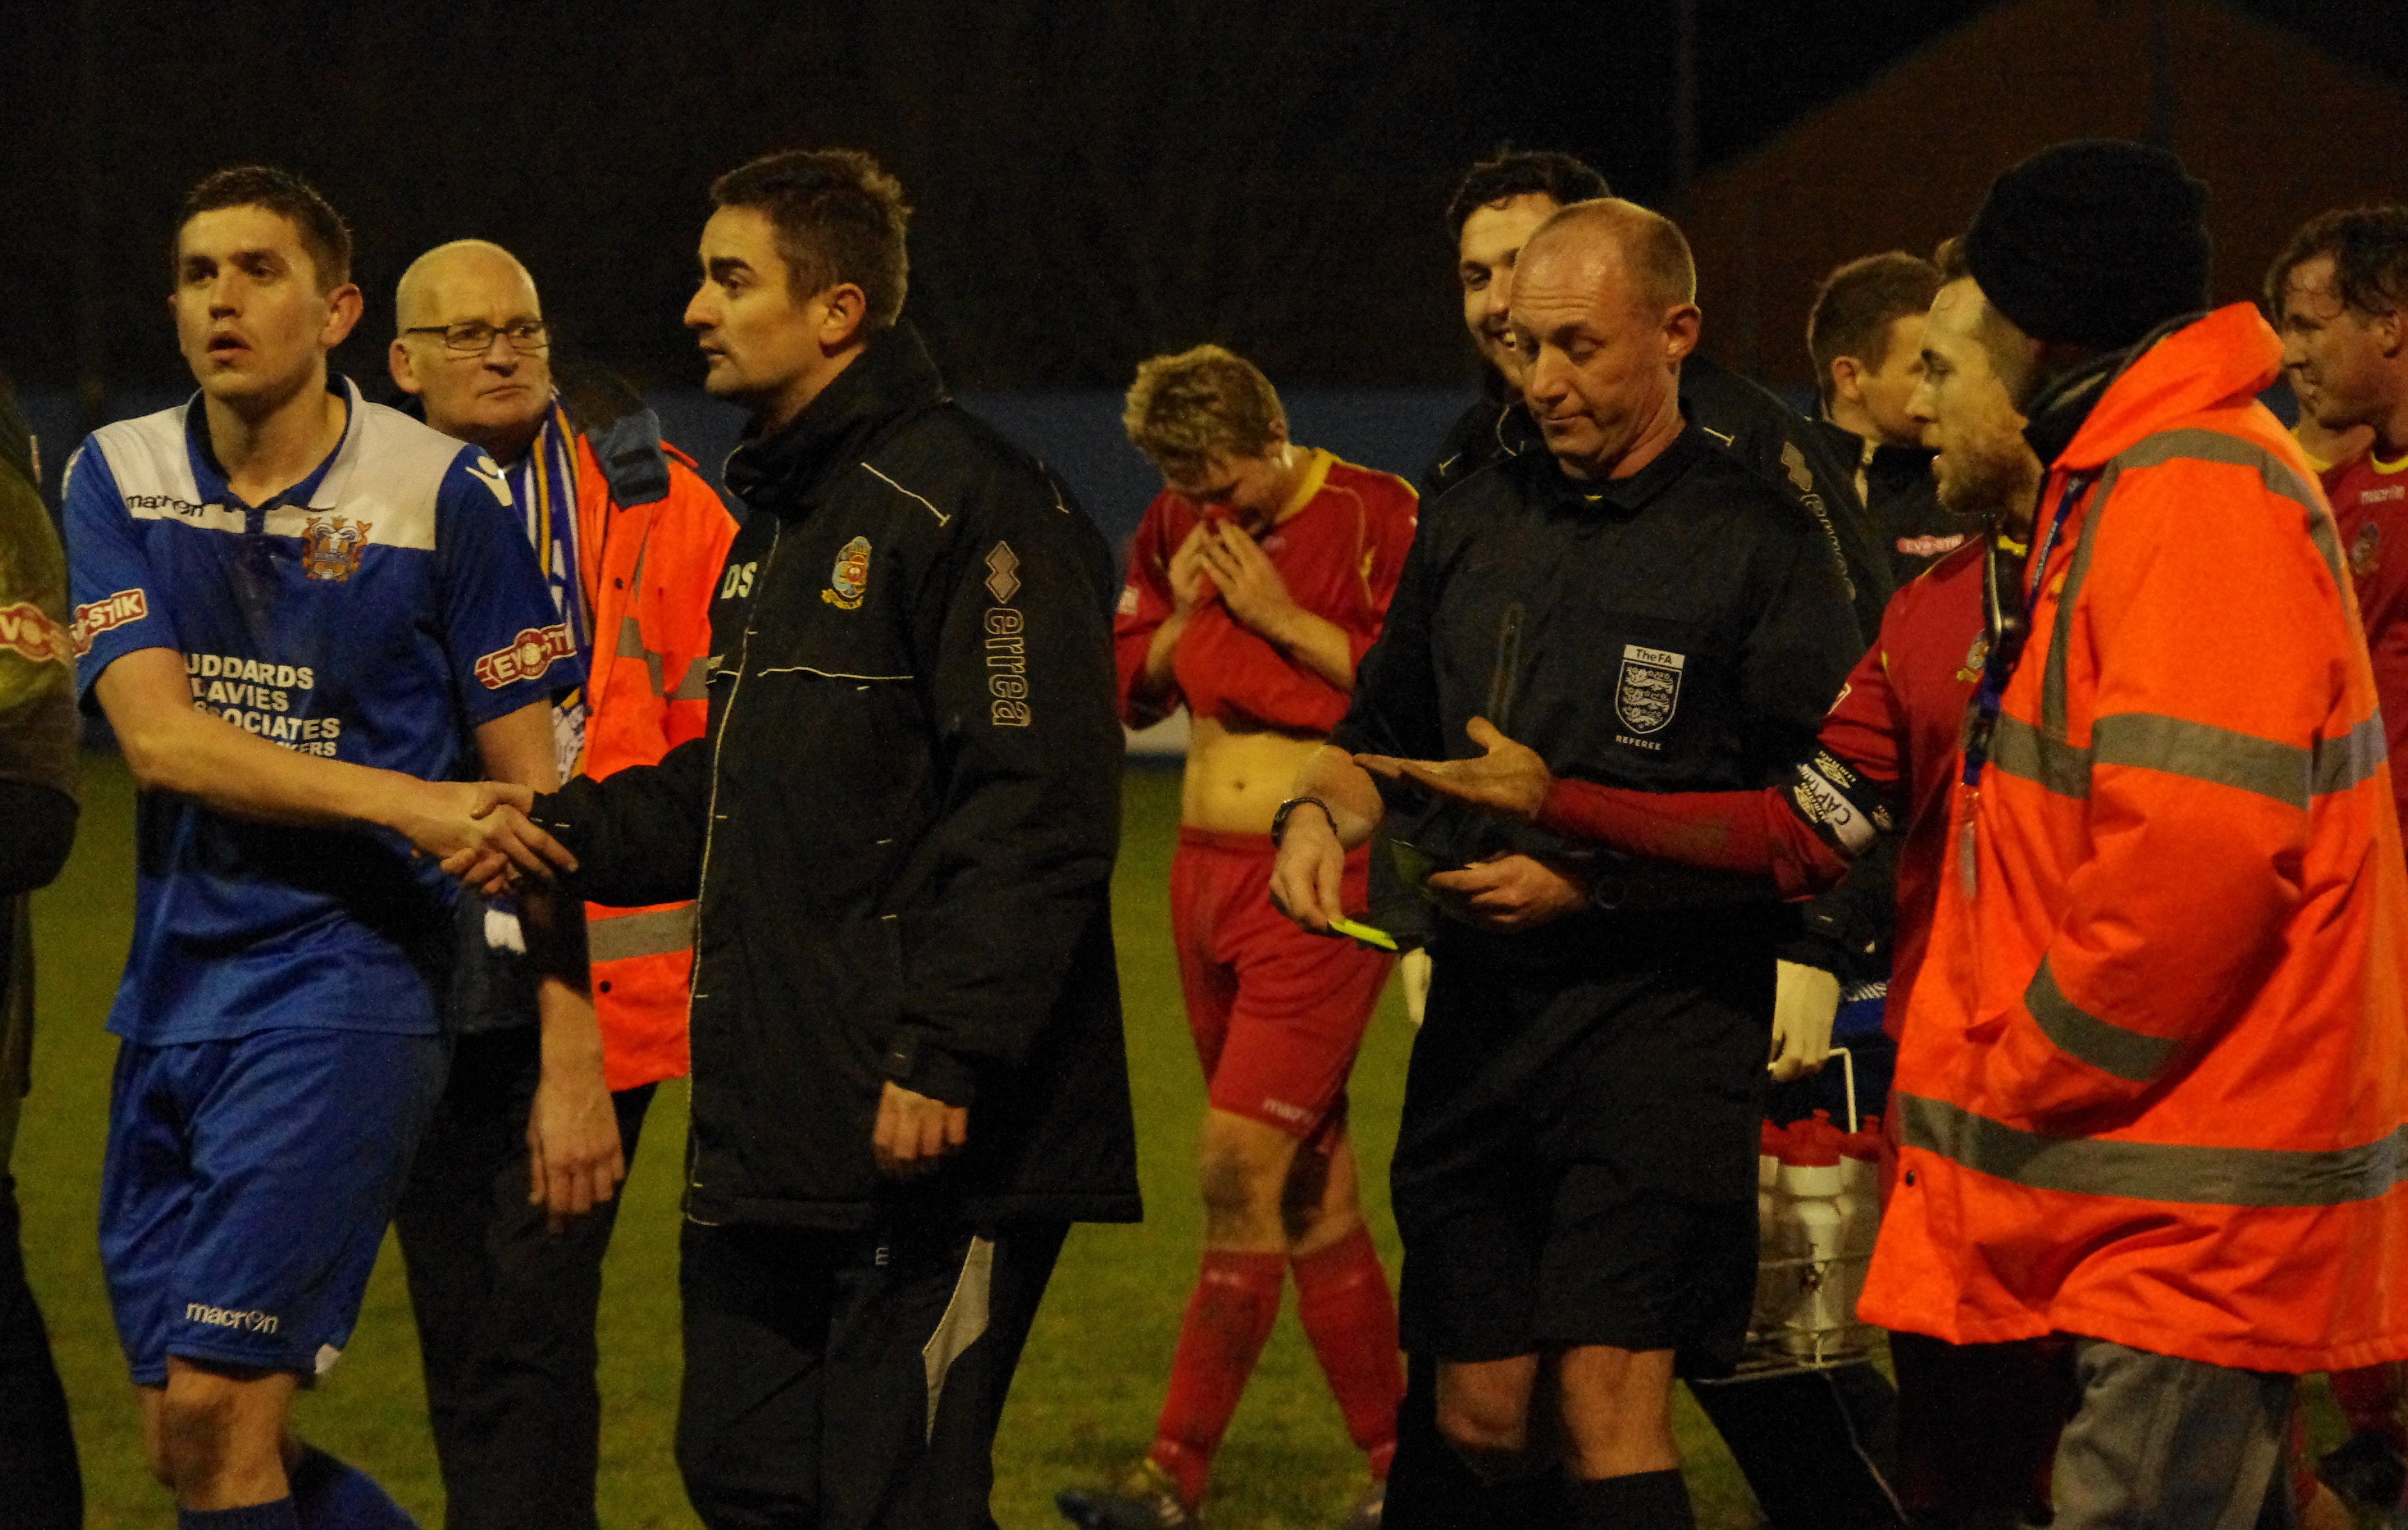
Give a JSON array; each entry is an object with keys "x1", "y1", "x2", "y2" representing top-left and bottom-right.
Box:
[{"x1": 1862, "y1": 304, "x2": 2408, "y2": 1371}]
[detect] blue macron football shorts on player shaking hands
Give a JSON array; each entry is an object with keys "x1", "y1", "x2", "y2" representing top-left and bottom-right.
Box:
[{"x1": 101, "y1": 1029, "x2": 448, "y2": 1385}]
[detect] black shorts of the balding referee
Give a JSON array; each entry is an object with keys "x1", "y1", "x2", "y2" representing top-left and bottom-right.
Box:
[{"x1": 1392, "y1": 920, "x2": 1773, "y2": 1378}]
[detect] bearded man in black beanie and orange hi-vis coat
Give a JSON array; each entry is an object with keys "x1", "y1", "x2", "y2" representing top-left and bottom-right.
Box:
[{"x1": 1859, "y1": 140, "x2": 2408, "y2": 1530}]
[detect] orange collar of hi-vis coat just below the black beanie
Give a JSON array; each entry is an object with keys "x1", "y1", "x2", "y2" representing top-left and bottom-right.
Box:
[{"x1": 2023, "y1": 304, "x2": 2283, "y2": 472}]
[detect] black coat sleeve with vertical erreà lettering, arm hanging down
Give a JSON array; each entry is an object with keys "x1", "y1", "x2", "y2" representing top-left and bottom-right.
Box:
[{"x1": 884, "y1": 465, "x2": 1122, "y2": 1106}]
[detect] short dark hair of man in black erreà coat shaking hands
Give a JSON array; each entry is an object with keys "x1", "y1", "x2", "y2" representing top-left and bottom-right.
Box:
[{"x1": 710, "y1": 149, "x2": 910, "y2": 335}]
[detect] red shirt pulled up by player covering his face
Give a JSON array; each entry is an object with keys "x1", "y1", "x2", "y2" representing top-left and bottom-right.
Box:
[{"x1": 1113, "y1": 450, "x2": 1418, "y2": 732}]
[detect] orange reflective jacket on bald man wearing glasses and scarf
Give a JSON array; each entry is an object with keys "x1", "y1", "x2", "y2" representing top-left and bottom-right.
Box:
[{"x1": 578, "y1": 434, "x2": 737, "y2": 1089}]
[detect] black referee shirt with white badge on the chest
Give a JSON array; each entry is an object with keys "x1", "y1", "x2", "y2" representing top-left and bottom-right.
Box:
[{"x1": 1332, "y1": 429, "x2": 1859, "y2": 886}]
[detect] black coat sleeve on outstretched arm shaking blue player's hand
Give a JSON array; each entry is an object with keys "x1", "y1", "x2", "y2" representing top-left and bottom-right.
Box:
[{"x1": 527, "y1": 732, "x2": 713, "y2": 909}]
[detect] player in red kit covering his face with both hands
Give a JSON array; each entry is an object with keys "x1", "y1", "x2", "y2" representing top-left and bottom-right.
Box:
[{"x1": 1060, "y1": 345, "x2": 1416, "y2": 1530}]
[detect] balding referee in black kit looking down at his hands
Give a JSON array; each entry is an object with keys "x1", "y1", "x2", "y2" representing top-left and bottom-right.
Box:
[{"x1": 1272, "y1": 200, "x2": 1859, "y2": 1530}]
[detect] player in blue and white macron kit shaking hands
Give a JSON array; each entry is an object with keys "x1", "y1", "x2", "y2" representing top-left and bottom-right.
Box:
[{"x1": 65, "y1": 166, "x2": 624, "y2": 1530}]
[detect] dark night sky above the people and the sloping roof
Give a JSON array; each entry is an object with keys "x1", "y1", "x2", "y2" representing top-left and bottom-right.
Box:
[{"x1": 0, "y1": 0, "x2": 2408, "y2": 407}]
